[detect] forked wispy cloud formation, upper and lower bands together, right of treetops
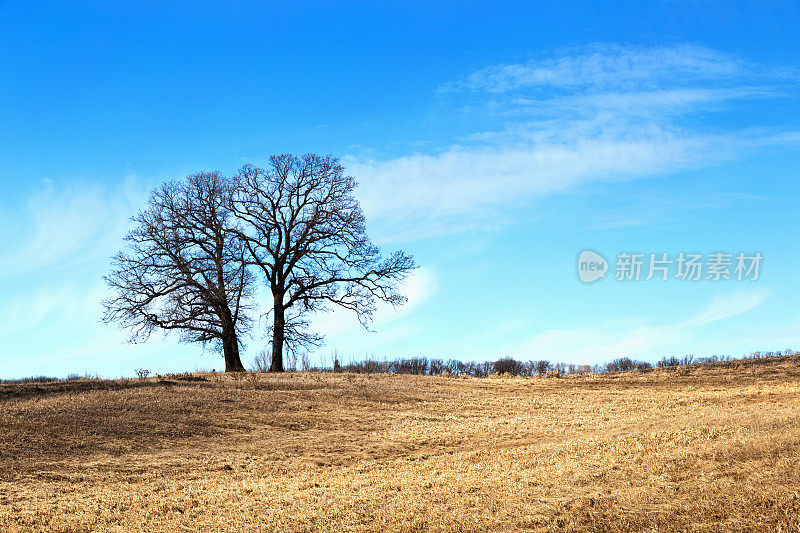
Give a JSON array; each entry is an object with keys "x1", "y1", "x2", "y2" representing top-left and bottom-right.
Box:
[{"x1": 354, "y1": 45, "x2": 800, "y2": 239}]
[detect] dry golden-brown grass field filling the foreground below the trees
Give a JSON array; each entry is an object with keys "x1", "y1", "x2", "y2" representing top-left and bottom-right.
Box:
[{"x1": 0, "y1": 357, "x2": 800, "y2": 532}]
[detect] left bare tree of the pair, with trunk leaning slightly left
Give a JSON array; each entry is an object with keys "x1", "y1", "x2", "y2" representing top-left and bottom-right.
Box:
[{"x1": 103, "y1": 172, "x2": 253, "y2": 371}]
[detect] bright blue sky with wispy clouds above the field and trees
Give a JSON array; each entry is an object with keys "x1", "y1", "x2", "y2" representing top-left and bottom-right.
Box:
[{"x1": 0, "y1": 1, "x2": 800, "y2": 378}]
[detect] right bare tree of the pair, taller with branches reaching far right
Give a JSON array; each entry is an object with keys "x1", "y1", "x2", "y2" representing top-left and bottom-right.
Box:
[{"x1": 231, "y1": 154, "x2": 416, "y2": 372}]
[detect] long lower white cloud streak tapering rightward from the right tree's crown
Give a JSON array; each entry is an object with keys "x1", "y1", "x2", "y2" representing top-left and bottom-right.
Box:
[{"x1": 347, "y1": 128, "x2": 796, "y2": 240}]
